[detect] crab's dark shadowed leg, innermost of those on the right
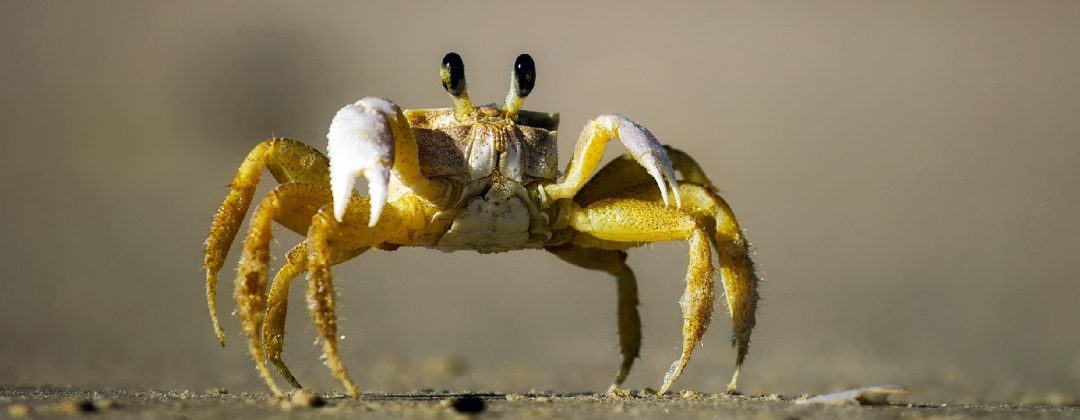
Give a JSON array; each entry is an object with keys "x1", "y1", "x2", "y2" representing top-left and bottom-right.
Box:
[{"x1": 548, "y1": 245, "x2": 642, "y2": 392}]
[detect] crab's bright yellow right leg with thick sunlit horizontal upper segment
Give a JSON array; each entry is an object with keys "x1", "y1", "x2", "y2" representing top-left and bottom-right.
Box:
[{"x1": 569, "y1": 199, "x2": 715, "y2": 394}]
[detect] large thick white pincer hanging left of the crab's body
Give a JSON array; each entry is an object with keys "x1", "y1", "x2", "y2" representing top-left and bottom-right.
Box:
[{"x1": 326, "y1": 97, "x2": 399, "y2": 226}]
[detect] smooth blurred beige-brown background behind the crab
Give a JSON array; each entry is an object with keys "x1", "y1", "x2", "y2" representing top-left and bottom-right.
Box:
[{"x1": 0, "y1": 1, "x2": 1080, "y2": 402}]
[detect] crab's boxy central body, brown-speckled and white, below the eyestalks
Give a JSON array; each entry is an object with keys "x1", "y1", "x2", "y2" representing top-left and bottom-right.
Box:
[{"x1": 389, "y1": 106, "x2": 558, "y2": 253}]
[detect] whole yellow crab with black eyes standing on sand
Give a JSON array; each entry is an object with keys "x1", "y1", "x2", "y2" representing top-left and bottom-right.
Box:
[{"x1": 203, "y1": 53, "x2": 758, "y2": 397}]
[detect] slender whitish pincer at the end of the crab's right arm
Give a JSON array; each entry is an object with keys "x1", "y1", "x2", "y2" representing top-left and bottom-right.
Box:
[{"x1": 596, "y1": 114, "x2": 683, "y2": 207}]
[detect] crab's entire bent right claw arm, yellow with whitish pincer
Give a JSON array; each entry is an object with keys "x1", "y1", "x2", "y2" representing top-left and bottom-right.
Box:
[{"x1": 544, "y1": 114, "x2": 681, "y2": 207}]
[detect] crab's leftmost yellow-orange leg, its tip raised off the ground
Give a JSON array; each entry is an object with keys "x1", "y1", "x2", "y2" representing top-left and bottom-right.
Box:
[{"x1": 203, "y1": 138, "x2": 329, "y2": 346}]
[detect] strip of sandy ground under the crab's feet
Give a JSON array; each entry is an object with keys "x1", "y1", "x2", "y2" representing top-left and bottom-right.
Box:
[{"x1": 6, "y1": 388, "x2": 1080, "y2": 419}]
